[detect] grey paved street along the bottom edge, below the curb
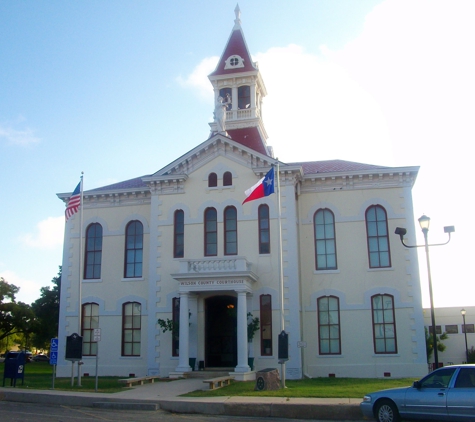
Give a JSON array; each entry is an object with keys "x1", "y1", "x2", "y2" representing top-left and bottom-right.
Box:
[{"x1": 0, "y1": 401, "x2": 366, "y2": 422}]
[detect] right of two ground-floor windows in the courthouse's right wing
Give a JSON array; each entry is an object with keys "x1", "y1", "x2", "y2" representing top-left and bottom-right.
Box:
[{"x1": 371, "y1": 295, "x2": 397, "y2": 353}]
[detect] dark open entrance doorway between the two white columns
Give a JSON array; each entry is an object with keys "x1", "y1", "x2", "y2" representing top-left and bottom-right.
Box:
[{"x1": 205, "y1": 296, "x2": 237, "y2": 368}]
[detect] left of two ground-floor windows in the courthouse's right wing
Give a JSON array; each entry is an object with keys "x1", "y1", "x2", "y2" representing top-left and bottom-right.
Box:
[{"x1": 317, "y1": 296, "x2": 341, "y2": 355}]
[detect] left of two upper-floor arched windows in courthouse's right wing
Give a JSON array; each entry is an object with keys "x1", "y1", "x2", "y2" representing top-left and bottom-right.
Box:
[{"x1": 314, "y1": 209, "x2": 337, "y2": 270}]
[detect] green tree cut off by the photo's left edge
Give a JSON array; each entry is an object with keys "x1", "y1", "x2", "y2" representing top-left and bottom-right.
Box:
[{"x1": 0, "y1": 277, "x2": 35, "y2": 340}]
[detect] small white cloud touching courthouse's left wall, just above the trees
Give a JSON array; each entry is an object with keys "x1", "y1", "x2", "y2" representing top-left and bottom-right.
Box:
[{"x1": 20, "y1": 216, "x2": 64, "y2": 249}]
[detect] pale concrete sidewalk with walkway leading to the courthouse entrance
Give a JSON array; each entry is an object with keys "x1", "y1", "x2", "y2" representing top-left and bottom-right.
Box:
[{"x1": 0, "y1": 378, "x2": 363, "y2": 421}]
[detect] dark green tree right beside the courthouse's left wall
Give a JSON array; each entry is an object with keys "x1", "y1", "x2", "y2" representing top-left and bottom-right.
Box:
[{"x1": 31, "y1": 266, "x2": 62, "y2": 349}]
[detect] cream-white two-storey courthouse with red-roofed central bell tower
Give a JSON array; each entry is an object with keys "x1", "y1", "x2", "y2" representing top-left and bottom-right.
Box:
[{"x1": 57, "y1": 10, "x2": 427, "y2": 380}]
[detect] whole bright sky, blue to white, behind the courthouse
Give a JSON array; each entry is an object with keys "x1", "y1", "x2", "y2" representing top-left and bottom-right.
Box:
[{"x1": 0, "y1": 0, "x2": 475, "y2": 308}]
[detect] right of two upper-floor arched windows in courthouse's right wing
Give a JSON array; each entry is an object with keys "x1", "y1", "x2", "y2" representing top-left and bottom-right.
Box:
[{"x1": 366, "y1": 205, "x2": 391, "y2": 268}]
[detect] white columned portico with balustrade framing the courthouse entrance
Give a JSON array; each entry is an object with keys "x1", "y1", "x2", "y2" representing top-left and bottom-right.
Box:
[{"x1": 172, "y1": 257, "x2": 258, "y2": 379}]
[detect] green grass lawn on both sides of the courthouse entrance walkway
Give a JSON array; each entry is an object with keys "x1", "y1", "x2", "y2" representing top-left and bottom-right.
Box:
[{"x1": 0, "y1": 362, "x2": 416, "y2": 398}]
